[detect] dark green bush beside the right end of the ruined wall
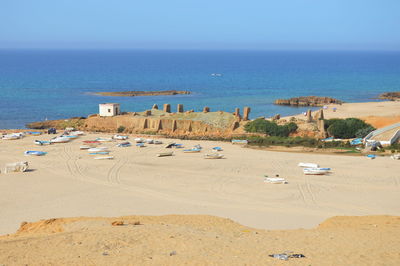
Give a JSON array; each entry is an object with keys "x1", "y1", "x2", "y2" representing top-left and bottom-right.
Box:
[{"x1": 244, "y1": 118, "x2": 297, "y2": 137}]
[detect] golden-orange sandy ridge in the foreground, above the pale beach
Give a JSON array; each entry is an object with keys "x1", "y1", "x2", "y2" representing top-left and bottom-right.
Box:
[{"x1": 0, "y1": 215, "x2": 400, "y2": 266}]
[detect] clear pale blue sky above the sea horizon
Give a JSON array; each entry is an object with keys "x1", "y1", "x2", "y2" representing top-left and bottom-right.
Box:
[{"x1": 0, "y1": 0, "x2": 400, "y2": 50}]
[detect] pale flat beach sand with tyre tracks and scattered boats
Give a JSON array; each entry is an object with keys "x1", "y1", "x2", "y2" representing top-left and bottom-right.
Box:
[{"x1": 0, "y1": 134, "x2": 400, "y2": 234}]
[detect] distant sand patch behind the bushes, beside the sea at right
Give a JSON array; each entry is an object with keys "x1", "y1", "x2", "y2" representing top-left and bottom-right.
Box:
[{"x1": 284, "y1": 101, "x2": 400, "y2": 128}]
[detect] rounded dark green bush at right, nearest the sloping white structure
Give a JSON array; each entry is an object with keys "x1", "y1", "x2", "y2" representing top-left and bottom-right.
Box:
[{"x1": 325, "y1": 118, "x2": 375, "y2": 139}]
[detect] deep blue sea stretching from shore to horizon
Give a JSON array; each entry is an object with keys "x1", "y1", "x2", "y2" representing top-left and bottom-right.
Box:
[{"x1": 0, "y1": 50, "x2": 400, "y2": 128}]
